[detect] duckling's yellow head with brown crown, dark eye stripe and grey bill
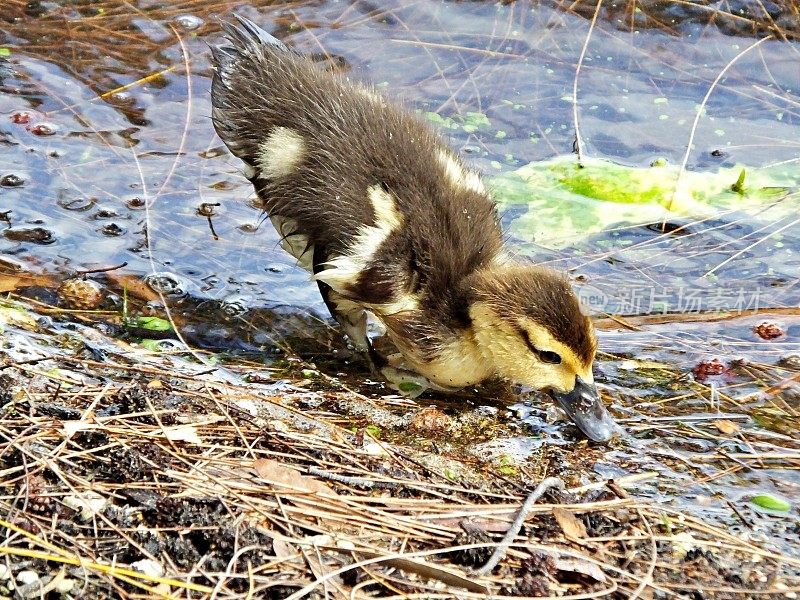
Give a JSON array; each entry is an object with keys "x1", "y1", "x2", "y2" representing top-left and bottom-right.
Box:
[{"x1": 468, "y1": 264, "x2": 619, "y2": 441}]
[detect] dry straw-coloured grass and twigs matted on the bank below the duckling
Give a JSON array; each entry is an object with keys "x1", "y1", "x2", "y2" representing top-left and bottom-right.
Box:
[{"x1": 0, "y1": 294, "x2": 800, "y2": 599}]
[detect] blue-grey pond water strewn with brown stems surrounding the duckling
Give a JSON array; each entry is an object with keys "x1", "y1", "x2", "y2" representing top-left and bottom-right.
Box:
[{"x1": 0, "y1": 0, "x2": 800, "y2": 552}]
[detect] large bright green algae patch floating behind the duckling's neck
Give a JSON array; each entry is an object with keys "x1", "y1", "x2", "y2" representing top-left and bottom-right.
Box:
[{"x1": 489, "y1": 155, "x2": 800, "y2": 248}]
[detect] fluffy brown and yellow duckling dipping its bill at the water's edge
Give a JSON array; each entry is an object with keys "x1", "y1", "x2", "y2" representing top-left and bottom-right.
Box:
[{"x1": 211, "y1": 16, "x2": 618, "y2": 441}]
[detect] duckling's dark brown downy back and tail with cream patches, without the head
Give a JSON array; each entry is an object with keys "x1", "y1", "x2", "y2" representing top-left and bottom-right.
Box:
[{"x1": 212, "y1": 18, "x2": 501, "y2": 314}]
